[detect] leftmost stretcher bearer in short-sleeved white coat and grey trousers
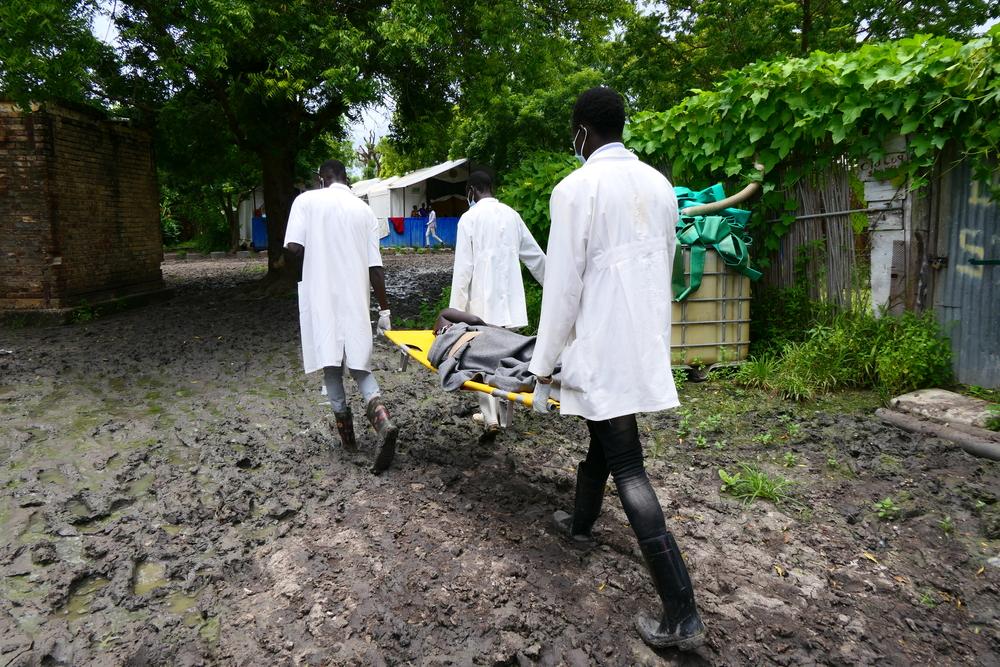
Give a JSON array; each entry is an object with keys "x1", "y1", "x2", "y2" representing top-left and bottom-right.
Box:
[{"x1": 285, "y1": 160, "x2": 398, "y2": 474}]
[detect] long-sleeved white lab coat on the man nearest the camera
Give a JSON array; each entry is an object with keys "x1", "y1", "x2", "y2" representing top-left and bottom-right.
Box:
[{"x1": 529, "y1": 144, "x2": 679, "y2": 421}]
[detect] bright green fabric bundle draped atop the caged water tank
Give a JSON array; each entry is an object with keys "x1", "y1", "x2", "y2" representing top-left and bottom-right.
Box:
[{"x1": 673, "y1": 183, "x2": 761, "y2": 301}]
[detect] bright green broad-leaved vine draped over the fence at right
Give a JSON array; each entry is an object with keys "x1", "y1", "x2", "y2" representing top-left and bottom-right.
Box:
[{"x1": 626, "y1": 27, "x2": 1000, "y2": 252}]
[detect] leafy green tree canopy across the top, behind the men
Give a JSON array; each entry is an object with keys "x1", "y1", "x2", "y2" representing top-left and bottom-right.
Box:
[{"x1": 0, "y1": 0, "x2": 1000, "y2": 270}]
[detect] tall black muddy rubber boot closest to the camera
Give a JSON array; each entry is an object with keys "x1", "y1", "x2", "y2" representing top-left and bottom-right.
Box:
[{"x1": 635, "y1": 531, "x2": 705, "y2": 651}]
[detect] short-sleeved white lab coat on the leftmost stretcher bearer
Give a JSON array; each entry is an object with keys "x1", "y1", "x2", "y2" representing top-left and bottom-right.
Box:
[{"x1": 285, "y1": 183, "x2": 382, "y2": 373}]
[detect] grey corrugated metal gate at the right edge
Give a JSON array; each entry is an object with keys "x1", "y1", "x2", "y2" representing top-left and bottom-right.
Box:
[{"x1": 934, "y1": 162, "x2": 1000, "y2": 388}]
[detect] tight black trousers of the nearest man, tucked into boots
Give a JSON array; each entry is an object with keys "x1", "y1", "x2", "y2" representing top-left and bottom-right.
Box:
[{"x1": 582, "y1": 415, "x2": 667, "y2": 541}]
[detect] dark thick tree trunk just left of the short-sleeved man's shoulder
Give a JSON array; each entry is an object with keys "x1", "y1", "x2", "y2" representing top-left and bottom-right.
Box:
[{"x1": 260, "y1": 147, "x2": 298, "y2": 280}]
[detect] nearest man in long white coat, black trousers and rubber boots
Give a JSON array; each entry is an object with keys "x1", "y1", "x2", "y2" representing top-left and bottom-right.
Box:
[{"x1": 529, "y1": 87, "x2": 704, "y2": 649}]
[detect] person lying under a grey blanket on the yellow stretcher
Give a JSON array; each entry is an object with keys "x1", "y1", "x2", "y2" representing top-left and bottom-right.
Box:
[{"x1": 427, "y1": 308, "x2": 558, "y2": 398}]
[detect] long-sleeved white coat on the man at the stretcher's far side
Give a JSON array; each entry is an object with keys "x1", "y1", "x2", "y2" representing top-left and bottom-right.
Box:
[{"x1": 449, "y1": 197, "x2": 545, "y2": 327}]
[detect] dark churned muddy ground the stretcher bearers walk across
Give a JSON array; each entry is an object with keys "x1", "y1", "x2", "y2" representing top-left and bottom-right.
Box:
[{"x1": 0, "y1": 254, "x2": 1000, "y2": 665}]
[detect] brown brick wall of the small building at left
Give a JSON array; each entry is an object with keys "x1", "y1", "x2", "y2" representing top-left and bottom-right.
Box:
[{"x1": 0, "y1": 103, "x2": 163, "y2": 309}]
